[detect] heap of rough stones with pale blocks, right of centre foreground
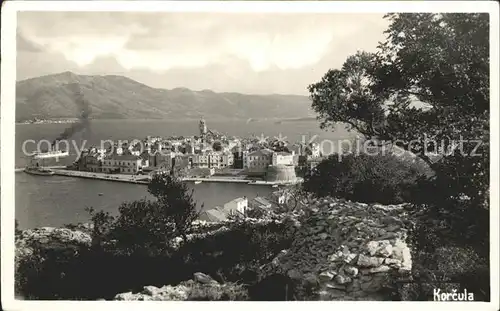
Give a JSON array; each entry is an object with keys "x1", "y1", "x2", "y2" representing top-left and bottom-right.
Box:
[{"x1": 262, "y1": 199, "x2": 413, "y2": 300}]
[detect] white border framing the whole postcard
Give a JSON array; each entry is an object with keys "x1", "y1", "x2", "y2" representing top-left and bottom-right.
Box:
[{"x1": 1, "y1": 1, "x2": 500, "y2": 311}]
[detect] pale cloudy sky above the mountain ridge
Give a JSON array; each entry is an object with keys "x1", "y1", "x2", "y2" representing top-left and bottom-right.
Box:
[{"x1": 17, "y1": 12, "x2": 388, "y2": 95}]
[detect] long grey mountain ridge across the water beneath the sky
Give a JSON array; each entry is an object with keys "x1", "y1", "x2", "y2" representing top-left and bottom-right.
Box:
[{"x1": 16, "y1": 72, "x2": 313, "y2": 121}]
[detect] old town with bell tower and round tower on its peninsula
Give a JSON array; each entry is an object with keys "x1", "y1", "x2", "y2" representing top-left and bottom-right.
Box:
[{"x1": 28, "y1": 118, "x2": 323, "y2": 186}]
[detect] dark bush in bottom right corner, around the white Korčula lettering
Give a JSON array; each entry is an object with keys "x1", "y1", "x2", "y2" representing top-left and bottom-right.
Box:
[{"x1": 397, "y1": 208, "x2": 490, "y2": 301}]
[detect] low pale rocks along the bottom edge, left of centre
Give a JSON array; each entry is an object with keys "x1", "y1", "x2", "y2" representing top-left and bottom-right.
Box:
[{"x1": 114, "y1": 272, "x2": 247, "y2": 301}]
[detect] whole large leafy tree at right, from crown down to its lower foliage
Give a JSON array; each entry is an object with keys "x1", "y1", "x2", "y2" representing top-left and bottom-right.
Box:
[{"x1": 309, "y1": 13, "x2": 490, "y2": 238}]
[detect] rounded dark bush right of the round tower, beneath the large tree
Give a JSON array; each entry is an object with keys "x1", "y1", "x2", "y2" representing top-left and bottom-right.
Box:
[{"x1": 303, "y1": 154, "x2": 424, "y2": 204}]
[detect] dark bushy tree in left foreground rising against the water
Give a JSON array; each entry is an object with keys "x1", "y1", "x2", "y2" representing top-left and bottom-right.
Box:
[{"x1": 88, "y1": 174, "x2": 203, "y2": 255}]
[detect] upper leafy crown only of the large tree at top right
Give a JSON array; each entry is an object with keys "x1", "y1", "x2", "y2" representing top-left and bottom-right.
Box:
[{"x1": 309, "y1": 14, "x2": 489, "y2": 166}]
